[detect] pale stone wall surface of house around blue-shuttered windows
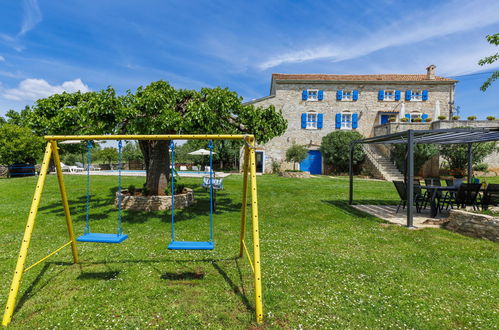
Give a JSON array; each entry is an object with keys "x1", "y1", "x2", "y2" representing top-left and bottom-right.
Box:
[{"x1": 245, "y1": 81, "x2": 453, "y2": 171}]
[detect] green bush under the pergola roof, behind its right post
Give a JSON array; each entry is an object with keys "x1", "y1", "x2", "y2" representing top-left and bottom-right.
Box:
[{"x1": 440, "y1": 142, "x2": 497, "y2": 173}]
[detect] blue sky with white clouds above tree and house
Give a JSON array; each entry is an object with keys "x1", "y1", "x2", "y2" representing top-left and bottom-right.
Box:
[{"x1": 0, "y1": 0, "x2": 499, "y2": 118}]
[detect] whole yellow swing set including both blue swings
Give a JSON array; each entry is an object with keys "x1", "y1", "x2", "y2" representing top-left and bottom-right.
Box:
[{"x1": 2, "y1": 135, "x2": 263, "y2": 326}]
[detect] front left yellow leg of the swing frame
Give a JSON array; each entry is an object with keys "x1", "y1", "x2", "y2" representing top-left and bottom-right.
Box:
[{"x1": 2, "y1": 142, "x2": 52, "y2": 326}]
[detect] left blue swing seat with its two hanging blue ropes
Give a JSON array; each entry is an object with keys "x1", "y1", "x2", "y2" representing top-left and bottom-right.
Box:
[{"x1": 76, "y1": 141, "x2": 128, "y2": 243}]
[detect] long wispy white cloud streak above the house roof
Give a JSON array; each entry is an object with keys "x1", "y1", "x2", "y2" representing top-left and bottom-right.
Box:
[{"x1": 258, "y1": 0, "x2": 499, "y2": 70}]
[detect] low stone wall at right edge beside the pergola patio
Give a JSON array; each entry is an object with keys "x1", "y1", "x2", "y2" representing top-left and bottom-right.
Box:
[{"x1": 445, "y1": 210, "x2": 499, "y2": 242}]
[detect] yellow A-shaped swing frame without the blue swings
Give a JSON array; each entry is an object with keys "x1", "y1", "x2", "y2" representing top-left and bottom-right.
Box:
[{"x1": 2, "y1": 134, "x2": 263, "y2": 326}]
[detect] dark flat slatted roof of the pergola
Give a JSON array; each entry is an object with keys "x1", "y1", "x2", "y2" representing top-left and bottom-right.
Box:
[{"x1": 354, "y1": 127, "x2": 499, "y2": 144}]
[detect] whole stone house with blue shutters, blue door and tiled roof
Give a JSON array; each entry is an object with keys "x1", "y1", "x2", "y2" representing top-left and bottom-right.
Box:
[{"x1": 247, "y1": 65, "x2": 457, "y2": 174}]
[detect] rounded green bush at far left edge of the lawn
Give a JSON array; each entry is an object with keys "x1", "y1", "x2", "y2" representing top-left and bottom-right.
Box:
[{"x1": 0, "y1": 124, "x2": 44, "y2": 165}]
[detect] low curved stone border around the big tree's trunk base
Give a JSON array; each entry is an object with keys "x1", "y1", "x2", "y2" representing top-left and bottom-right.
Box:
[{"x1": 114, "y1": 188, "x2": 196, "y2": 212}]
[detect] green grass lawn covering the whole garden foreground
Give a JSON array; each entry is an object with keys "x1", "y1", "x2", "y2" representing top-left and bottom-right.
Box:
[{"x1": 0, "y1": 175, "x2": 499, "y2": 328}]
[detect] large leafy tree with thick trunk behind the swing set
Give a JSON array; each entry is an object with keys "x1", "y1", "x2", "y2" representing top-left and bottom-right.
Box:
[{"x1": 15, "y1": 81, "x2": 287, "y2": 195}]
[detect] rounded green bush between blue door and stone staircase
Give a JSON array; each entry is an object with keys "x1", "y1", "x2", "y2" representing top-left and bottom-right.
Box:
[{"x1": 321, "y1": 131, "x2": 365, "y2": 172}]
